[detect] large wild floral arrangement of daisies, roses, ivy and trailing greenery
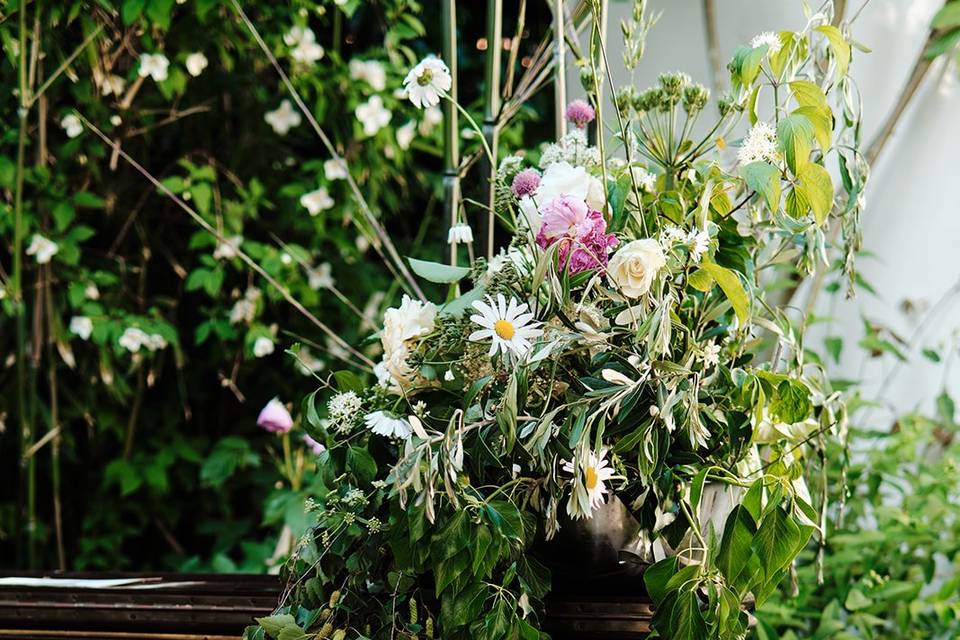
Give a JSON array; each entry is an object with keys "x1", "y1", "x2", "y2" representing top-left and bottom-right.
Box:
[{"x1": 250, "y1": 5, "x2": 867, "y2": 640}]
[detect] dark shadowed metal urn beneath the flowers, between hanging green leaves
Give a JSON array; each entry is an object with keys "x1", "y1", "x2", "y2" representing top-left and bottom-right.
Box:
[{"x1": 535, "y1": 497, "x2": 653, "y2": 640}]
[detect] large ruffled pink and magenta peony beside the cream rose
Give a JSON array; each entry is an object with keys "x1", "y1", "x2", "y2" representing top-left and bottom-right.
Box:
[{"x1": 537, "y1": 196, "x2": 618, "y2": 274}]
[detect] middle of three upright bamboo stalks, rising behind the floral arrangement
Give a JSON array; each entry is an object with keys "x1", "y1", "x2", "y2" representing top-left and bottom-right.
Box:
[{"x1": 479, "y1": 0, "x2": 502, "y2": 258}]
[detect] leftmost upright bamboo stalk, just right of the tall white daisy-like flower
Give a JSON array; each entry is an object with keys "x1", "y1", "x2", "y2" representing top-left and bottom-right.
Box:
[{"x1": 442, "y1": 0, "x2": 460, "y2": 265}]
